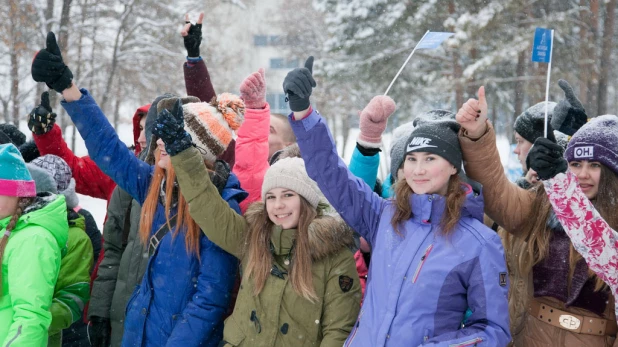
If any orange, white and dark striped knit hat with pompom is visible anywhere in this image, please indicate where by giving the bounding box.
[182,93,245,163]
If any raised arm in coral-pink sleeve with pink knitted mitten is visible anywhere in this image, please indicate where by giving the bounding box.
[234,69,270,213]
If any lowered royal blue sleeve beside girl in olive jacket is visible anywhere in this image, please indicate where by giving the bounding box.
[165,236,238,347]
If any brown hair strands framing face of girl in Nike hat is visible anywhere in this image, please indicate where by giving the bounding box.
[391,175,466,236]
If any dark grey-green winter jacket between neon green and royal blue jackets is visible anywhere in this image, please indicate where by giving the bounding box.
[88,187,149,347]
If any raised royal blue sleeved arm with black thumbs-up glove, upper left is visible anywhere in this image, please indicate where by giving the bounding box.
[32,32,152,202]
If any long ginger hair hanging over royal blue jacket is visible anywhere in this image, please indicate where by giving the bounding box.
[139,149,202,259]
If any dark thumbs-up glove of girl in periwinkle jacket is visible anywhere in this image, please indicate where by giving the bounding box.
[283,56,316,112]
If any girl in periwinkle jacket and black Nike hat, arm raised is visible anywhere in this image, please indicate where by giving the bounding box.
[283,57,510,347]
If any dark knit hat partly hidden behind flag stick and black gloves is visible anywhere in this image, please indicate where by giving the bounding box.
[514,102,556,143]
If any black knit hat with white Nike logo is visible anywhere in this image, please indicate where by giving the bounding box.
[406,120,462,172]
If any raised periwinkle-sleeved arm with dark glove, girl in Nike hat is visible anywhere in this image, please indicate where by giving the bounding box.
[283,57,384,244]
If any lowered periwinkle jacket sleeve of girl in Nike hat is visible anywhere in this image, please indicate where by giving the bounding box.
[423,234,511,347]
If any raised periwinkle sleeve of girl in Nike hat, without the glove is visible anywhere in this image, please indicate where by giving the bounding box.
[289,110,384,244]
